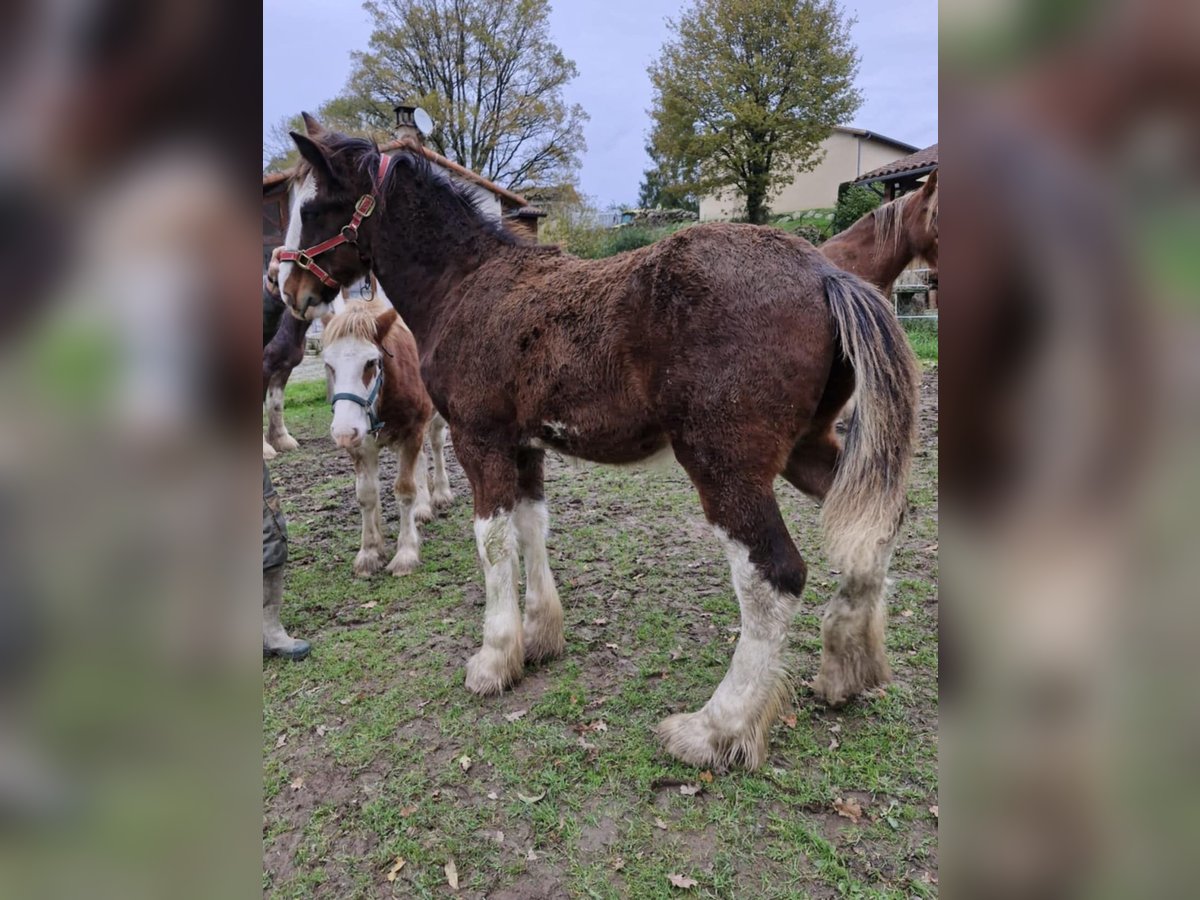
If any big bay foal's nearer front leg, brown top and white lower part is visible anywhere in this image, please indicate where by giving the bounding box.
[455,432,524,695]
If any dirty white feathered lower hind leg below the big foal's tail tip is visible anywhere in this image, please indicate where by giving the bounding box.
[812,568,892,706]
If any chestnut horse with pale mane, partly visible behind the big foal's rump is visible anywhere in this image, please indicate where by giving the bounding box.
[821,169,937,295]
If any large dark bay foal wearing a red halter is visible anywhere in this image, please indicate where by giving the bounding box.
[280,116,918,769]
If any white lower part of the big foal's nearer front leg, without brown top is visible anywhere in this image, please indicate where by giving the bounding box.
[467,510,524,694]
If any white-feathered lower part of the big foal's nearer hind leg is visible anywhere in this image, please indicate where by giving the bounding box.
[659,528,799,769]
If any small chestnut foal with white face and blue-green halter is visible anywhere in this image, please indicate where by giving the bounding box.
[321,300,454,576]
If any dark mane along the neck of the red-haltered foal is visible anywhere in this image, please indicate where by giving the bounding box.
[309,132,524,245]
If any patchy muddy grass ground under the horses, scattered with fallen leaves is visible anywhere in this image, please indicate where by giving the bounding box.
[263,369,937,900]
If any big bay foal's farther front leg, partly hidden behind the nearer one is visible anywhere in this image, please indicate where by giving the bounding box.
[512,450,564,662]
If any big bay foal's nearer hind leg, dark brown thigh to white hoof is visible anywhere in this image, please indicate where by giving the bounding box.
[658,460,806,769]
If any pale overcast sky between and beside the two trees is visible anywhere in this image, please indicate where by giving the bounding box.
[263,0,937,205]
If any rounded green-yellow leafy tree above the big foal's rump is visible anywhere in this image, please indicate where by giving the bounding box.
[649,0,862,222]
